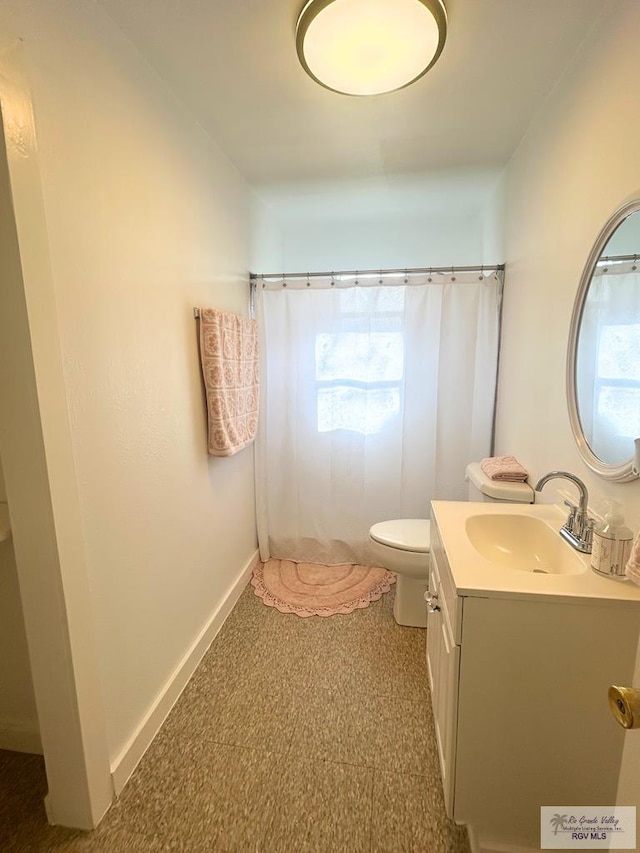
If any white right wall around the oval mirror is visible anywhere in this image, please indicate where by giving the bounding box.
[497,0,640,806]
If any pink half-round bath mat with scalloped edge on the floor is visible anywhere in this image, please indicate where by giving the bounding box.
[251,560,396,616]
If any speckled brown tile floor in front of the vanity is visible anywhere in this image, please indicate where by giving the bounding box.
[0,586,469,853]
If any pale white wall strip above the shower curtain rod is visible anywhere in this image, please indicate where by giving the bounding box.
[251,170,497,273]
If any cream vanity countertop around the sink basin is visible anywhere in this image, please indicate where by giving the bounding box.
[431,501,640,606]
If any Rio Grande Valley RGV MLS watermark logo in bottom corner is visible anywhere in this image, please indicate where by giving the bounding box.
[540,806,637,850]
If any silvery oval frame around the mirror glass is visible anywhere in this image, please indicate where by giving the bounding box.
[566,198,640,483]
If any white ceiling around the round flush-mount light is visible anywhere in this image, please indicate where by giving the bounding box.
[99,0,607,201]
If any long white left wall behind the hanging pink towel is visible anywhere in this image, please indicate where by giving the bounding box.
[0,0,255,776]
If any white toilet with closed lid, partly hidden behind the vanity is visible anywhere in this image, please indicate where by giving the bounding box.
[369,462,535,628]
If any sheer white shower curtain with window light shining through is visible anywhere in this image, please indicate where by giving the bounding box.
[256,272,502,564]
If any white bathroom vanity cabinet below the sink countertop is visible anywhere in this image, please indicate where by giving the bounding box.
[427,503,640,851]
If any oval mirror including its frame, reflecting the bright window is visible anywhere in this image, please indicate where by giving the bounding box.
[567,200,640,482]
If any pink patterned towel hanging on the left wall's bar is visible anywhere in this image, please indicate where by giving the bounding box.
[200,308,259,456]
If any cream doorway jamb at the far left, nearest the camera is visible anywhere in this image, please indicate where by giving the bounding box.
[0,76,113,828]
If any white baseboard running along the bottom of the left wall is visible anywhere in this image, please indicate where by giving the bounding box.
[111,550,259,796]
